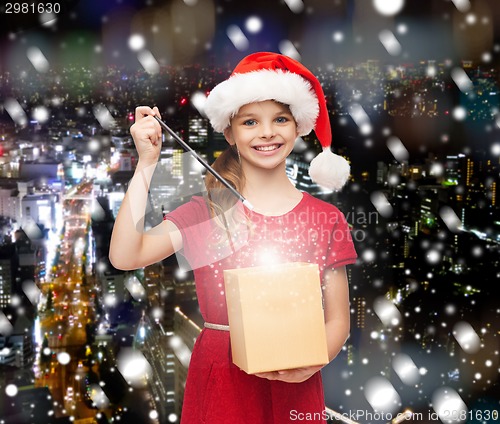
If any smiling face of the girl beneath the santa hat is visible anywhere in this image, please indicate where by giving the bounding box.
[224,100,298,169]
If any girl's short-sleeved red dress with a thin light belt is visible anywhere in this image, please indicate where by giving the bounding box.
[165,193,356,424]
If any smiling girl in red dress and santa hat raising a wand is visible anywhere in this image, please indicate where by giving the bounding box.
[110,53,356,424]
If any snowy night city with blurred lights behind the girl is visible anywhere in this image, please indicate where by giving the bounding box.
[0,0,500,424]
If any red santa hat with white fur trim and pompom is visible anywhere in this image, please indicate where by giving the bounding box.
[204,52,350,190]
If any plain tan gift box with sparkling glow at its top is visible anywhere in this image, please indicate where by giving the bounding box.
[224,262,328,374]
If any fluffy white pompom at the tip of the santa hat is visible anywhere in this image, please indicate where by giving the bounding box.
[309,147,351,191]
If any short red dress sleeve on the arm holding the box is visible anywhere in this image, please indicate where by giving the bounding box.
[326,209,358,268]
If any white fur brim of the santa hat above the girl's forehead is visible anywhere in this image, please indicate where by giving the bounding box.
[204,69,319,136]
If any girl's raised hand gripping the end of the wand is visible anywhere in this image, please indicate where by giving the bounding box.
[130,106,162,164]
